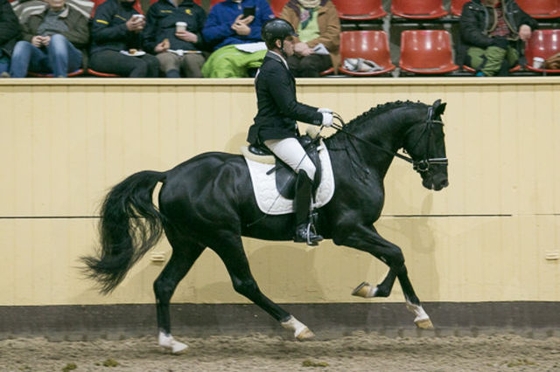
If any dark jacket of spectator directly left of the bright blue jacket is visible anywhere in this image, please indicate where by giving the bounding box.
[143,0,206,53]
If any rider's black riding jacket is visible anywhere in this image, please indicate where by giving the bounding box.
[247,51,323,145]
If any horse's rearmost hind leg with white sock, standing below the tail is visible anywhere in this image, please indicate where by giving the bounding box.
[154,231,206,353]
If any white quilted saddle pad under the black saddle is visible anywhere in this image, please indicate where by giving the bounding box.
[241,145,334,215]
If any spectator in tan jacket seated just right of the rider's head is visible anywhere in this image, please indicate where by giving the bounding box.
[280,0,340,77]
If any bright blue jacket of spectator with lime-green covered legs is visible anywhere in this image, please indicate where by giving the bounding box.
[202,0,274,50]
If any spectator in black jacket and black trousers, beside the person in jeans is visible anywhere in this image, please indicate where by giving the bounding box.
[89,0,159,77]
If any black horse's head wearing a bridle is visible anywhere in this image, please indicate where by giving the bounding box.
[404,99,449,191]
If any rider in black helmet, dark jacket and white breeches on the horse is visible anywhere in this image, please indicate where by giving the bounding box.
[247,18,333,245]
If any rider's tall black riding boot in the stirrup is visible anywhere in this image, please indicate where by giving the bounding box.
[294,170,323,245]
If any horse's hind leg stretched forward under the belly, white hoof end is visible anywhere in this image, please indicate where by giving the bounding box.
[214,237,315,341]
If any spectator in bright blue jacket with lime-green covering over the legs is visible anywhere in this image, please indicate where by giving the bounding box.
[202,0,274,78]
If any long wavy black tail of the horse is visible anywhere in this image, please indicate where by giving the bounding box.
[81,171,165,294]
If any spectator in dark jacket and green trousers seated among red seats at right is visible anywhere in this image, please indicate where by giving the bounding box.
[459,0,538,76]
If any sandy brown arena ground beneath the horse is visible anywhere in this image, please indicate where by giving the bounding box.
[0,332,560,372]
